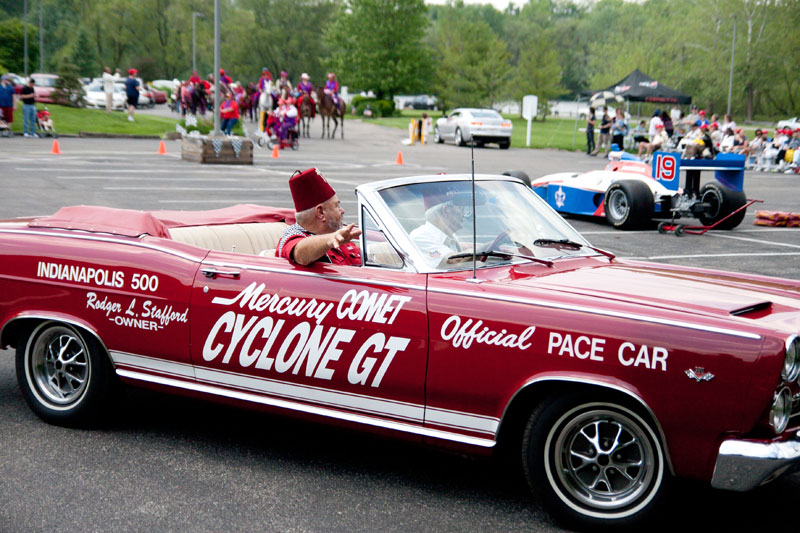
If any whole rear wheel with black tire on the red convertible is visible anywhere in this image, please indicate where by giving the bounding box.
[16,321,115,427]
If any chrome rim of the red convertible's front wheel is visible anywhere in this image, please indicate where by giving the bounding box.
[554,410,655,510]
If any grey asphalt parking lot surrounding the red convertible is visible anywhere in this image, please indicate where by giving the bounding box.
[0,122,800,531]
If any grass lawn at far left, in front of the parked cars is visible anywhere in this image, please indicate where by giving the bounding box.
[11,102,178,136]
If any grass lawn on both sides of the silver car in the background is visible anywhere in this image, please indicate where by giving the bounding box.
[364,109,586,150]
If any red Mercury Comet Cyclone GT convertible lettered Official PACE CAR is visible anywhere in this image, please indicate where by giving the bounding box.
[0,175,800,527]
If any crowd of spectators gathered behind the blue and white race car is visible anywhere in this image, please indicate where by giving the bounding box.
[586,105,800,172]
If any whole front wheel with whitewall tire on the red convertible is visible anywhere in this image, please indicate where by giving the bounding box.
[522,394,671,531]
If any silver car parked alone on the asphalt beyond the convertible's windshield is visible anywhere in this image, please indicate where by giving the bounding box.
[433,108,514,149]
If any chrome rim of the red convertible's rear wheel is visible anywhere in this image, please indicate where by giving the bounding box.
[26,326,91,409]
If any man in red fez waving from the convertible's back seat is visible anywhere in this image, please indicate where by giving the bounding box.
[275,168,361,266]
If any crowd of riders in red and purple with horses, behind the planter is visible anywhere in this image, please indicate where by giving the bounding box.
[171,67,341,141]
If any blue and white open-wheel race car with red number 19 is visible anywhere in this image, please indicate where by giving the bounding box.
[531,152,747,230]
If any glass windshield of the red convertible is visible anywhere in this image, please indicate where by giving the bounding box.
[380,179,595,270]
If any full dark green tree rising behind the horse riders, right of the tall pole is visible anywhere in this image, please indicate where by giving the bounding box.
[325,0,430,99]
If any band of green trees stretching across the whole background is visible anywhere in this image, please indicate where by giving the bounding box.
[0,0,800,120]
